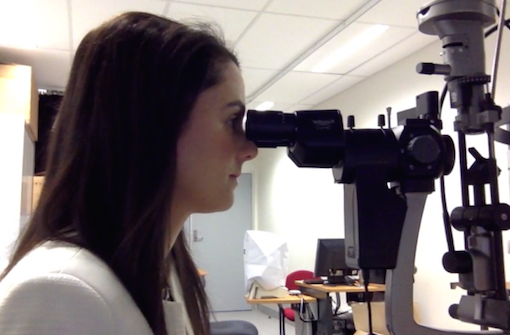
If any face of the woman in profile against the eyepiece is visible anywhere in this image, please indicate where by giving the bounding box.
[173,62,257,214]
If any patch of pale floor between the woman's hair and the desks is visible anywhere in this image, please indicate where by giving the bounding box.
[209,311,295,335]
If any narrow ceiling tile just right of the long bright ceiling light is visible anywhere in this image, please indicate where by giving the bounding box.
[349,32,440,76]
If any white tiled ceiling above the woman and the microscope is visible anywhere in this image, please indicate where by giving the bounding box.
[0,0,437,111]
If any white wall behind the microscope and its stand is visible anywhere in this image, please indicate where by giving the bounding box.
[257,17,510,329]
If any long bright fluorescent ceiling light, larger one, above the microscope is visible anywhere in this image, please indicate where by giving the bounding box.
[312,24,388,72]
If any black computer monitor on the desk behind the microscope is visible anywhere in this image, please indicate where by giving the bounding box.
[315,238,358,284]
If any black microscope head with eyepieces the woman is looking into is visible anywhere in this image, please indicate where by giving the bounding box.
[245,110,454,183]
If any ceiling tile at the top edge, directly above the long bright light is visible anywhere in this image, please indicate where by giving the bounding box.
[266,0,368,20]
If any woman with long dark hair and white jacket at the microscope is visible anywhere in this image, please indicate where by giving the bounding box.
[0,13,257,335]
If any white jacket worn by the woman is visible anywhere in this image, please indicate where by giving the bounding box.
[0,242,192,335]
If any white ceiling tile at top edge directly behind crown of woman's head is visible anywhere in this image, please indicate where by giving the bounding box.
[72,0,166,49]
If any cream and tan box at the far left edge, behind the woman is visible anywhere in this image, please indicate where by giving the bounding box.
[0,63,39,142]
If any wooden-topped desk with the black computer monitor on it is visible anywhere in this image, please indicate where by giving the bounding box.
[295,280,386,335]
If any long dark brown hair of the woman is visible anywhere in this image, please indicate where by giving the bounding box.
[0,12,239,335]
